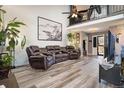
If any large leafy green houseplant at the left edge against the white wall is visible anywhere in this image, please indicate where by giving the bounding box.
[0,9,26,79]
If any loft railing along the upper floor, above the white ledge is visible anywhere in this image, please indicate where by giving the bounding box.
[69,5,124,26]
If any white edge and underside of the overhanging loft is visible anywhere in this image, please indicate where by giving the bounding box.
[67,15,124,33]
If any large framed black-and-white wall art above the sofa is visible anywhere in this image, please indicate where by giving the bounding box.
[38,16,62,41]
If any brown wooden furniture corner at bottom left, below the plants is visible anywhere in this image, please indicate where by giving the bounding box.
[0,71,19,88]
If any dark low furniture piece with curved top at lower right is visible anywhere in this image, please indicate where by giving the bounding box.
[99,65,122,85]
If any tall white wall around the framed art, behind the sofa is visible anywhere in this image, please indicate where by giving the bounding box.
[3,5,69,66]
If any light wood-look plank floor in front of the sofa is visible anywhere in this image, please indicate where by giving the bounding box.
[12,57,123,88]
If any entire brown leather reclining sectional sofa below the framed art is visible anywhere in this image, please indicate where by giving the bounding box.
[26,45,80,69]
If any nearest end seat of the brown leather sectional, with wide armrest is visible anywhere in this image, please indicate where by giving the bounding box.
[26,46,55,70]
